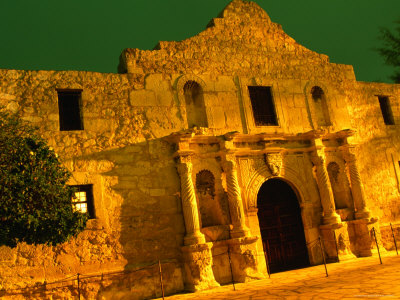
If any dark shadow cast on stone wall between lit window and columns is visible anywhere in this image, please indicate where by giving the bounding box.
[82,139,185,298]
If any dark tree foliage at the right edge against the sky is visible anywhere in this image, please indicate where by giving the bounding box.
[377,20,400,83]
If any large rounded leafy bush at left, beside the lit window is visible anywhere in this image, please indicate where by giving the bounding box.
[0,107,87,247]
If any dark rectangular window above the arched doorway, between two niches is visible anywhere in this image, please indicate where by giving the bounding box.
[248,86,278,126]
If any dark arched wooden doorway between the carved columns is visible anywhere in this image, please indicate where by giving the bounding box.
[257,178,310,272]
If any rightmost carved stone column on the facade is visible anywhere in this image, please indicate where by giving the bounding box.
[340,145,370,219]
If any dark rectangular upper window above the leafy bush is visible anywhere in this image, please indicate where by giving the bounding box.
[58,91,83,131]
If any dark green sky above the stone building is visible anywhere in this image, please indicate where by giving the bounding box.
[0,0,400,82]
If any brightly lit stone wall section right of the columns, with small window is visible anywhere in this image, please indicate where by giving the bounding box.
[349,82,400,222]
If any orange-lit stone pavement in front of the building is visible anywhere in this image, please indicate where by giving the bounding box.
[159,252,400,300]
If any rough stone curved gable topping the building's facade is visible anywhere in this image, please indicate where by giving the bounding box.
[119,0,338,76]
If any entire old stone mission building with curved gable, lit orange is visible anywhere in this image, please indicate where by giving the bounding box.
[0,0,400,299]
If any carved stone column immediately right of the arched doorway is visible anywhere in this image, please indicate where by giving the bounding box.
[311,151,341,225]
